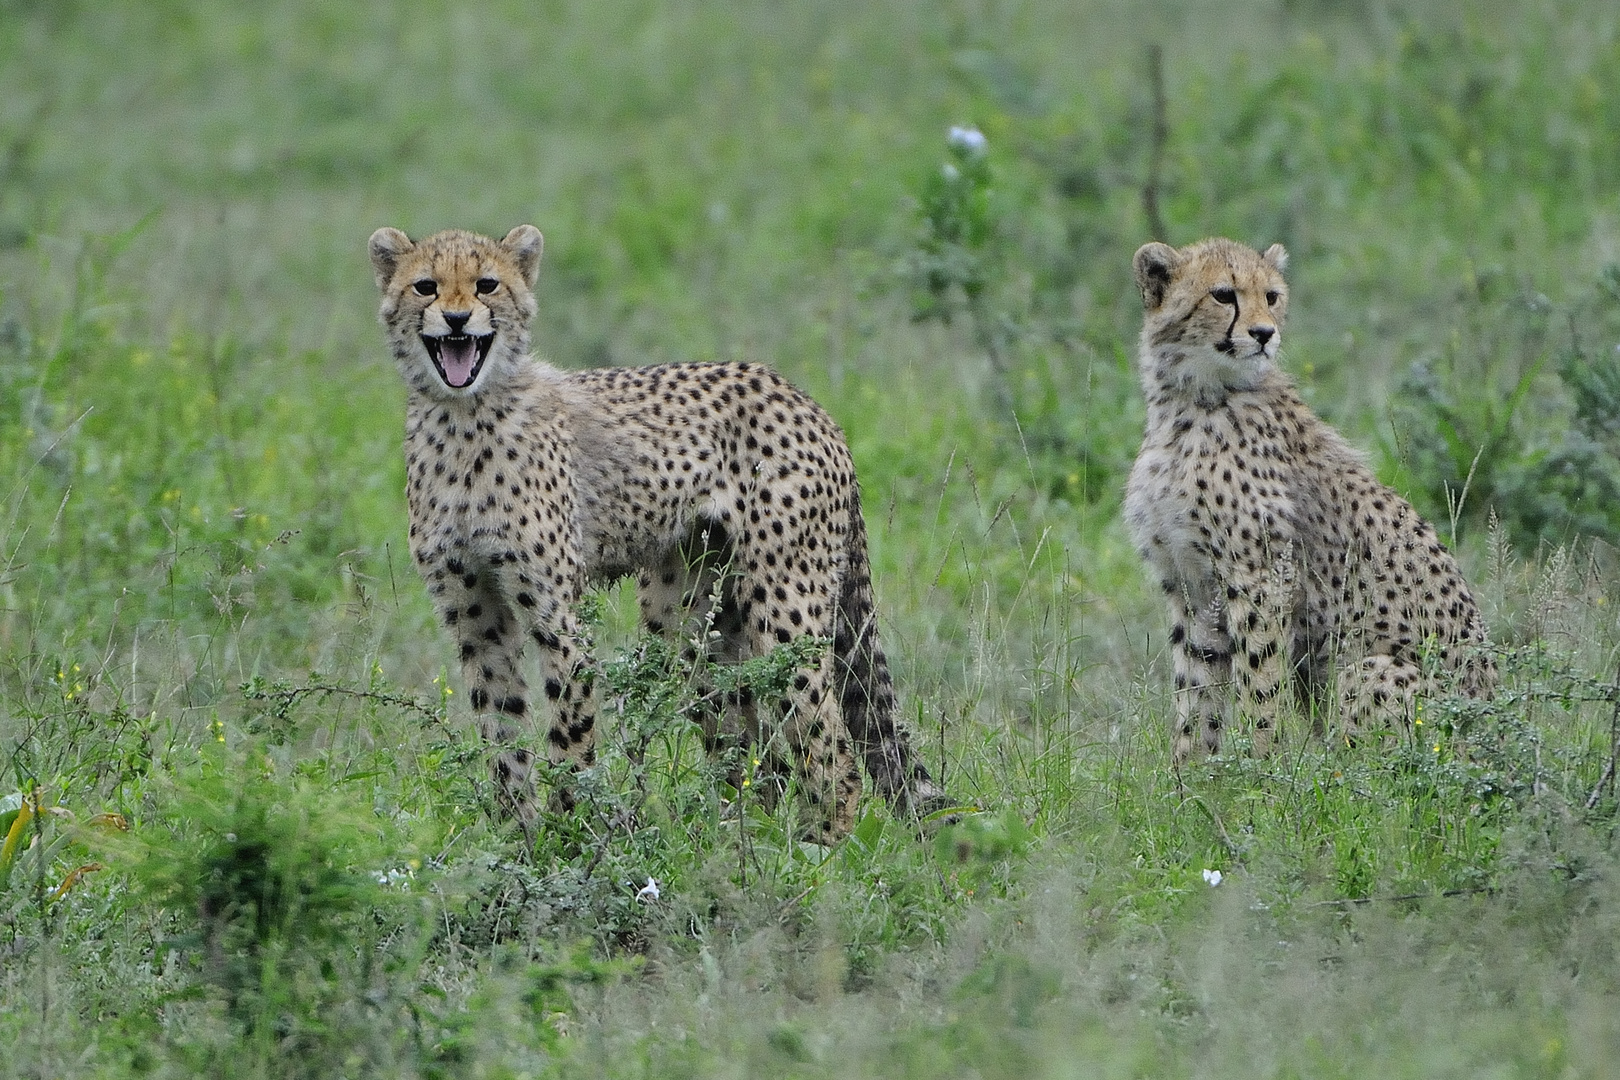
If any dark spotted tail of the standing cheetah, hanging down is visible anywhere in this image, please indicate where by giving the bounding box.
[833,486,953,814]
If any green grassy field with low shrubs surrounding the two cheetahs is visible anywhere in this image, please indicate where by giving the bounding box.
[0,0,1620,1078]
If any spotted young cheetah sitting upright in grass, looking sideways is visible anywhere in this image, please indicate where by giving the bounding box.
[1124,240,1495,764]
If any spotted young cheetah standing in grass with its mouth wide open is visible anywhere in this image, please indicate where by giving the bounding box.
[371,225,946,840]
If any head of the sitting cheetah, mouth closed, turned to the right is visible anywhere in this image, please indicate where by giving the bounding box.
[1134,240,1288,400]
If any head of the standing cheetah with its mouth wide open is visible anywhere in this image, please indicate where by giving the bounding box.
[371,225,544,397]
